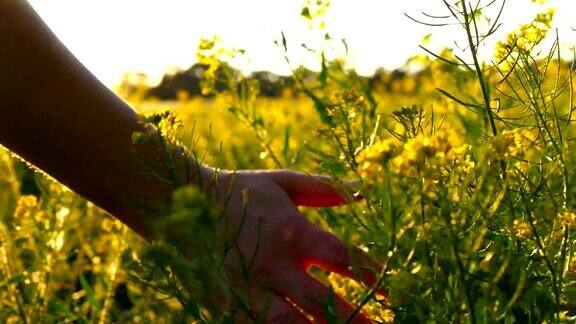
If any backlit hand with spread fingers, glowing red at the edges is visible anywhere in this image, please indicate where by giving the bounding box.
[209,170,380,323]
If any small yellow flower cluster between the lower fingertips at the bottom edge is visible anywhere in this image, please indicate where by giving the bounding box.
[328,273,395,323]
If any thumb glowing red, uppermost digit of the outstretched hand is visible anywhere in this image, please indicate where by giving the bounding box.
[270,170,358,207]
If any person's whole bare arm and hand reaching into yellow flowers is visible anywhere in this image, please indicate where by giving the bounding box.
[0,0,378,323]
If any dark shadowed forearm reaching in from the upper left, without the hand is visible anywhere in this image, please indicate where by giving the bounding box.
[0,0,207,235]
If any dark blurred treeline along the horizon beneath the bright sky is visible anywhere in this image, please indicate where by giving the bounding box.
[141,60,574,100]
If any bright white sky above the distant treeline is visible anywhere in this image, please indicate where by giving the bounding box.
[29,0,576,86]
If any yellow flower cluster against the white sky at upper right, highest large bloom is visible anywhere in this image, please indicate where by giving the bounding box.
[494,9,554,70]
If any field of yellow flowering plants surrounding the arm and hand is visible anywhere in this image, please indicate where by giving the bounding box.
[0,1,576,323]
